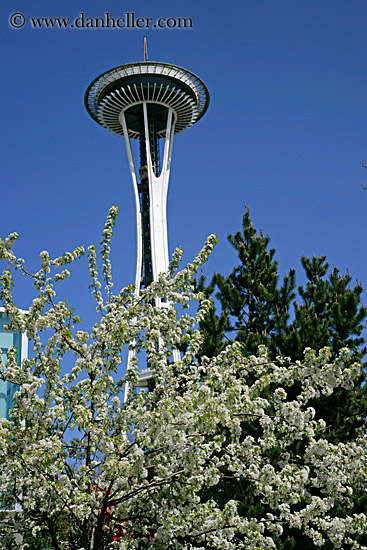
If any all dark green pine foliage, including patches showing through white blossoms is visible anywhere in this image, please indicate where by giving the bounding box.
[198,207,367,550]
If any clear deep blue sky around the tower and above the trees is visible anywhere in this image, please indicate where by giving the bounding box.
[0,0,367,328]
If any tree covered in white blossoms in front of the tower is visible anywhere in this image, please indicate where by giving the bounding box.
[0,208,367,550]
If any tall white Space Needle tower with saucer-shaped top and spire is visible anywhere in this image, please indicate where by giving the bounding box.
[85,41,209,398]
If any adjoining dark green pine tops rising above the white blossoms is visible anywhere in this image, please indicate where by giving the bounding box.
[198,207,367,370]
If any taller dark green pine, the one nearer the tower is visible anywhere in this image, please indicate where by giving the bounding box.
[199,207,295,355]
